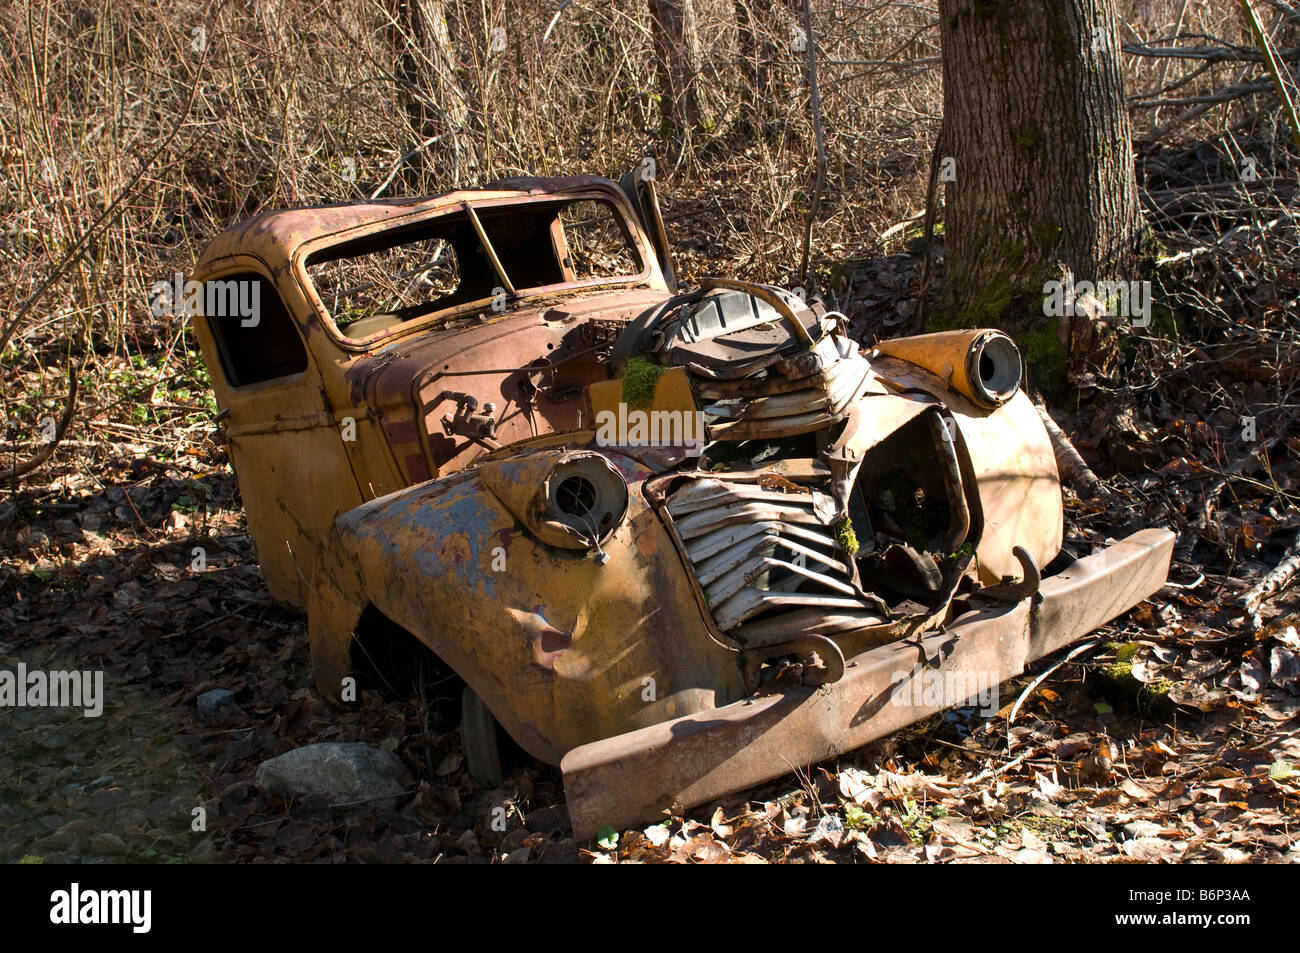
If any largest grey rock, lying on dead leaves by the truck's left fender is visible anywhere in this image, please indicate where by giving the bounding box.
[257,741,406,803]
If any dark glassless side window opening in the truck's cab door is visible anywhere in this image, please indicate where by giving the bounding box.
[198,272,307,387]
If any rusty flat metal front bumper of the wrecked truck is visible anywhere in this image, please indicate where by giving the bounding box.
[560,529,1174,840]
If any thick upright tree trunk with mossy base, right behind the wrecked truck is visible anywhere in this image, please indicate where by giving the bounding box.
[939,0,1144,393]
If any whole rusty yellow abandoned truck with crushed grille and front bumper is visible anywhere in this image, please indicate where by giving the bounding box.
[194,174,1174,839]
